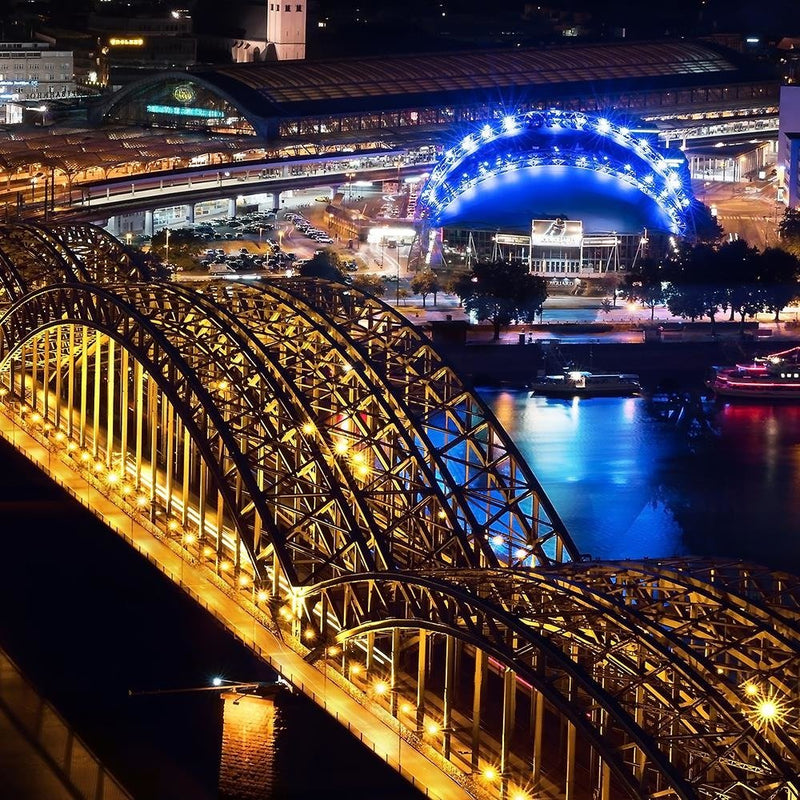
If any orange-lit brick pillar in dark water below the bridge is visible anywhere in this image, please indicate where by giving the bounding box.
[219,692,275,800]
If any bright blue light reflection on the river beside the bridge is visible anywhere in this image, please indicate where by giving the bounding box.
[484,392,685,558]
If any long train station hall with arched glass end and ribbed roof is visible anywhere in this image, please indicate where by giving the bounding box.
[95,41,779,153]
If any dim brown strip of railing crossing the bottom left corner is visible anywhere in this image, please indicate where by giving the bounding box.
[0,650,132,800]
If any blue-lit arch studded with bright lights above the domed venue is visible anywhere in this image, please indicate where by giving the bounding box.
[417,109,691,235]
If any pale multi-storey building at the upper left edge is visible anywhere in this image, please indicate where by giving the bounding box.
[0,42,75,124]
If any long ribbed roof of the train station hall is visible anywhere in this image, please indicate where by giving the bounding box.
[192,40,763,117]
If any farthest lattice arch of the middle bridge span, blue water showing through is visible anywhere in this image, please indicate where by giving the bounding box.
[282,280,577,563]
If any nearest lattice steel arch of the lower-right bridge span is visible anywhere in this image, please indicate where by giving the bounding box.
[300,570,700,800]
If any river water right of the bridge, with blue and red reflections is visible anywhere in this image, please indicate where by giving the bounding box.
[481,390,800,572]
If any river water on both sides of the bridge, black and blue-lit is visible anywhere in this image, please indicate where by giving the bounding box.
[0,391,800,800]
